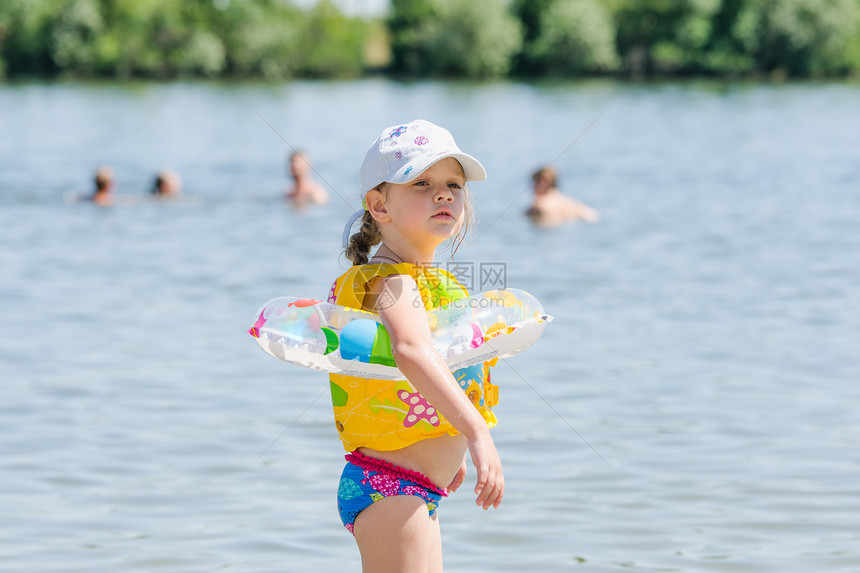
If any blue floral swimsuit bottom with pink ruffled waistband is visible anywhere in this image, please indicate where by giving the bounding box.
[337,452,448,535]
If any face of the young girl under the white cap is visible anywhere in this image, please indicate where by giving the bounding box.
[368,157,466,254]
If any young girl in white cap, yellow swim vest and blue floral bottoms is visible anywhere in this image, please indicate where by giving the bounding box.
[329,120,505,573]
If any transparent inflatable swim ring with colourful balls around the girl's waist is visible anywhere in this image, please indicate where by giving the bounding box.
[248,289,552,380]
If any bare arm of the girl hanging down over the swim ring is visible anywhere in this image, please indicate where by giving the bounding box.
[374,275,505,509]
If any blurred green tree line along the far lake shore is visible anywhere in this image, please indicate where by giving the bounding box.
[0,0,860,79]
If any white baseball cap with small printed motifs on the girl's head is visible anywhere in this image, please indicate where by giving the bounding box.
[358,119,487,194]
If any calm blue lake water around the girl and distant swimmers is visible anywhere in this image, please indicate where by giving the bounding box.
[0,80,860,573]
